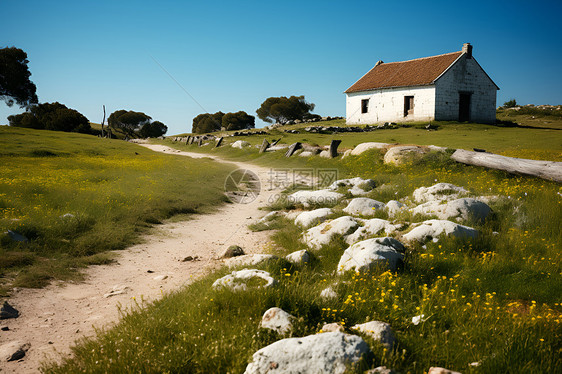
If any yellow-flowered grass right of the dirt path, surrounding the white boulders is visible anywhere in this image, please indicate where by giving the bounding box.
[44,117,562,373]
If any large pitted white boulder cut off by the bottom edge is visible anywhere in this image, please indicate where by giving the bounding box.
[244,332,371,374]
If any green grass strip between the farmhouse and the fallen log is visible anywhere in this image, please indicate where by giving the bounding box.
[170,112,562,161]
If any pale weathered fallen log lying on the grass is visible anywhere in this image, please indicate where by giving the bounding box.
[451,149,562,183]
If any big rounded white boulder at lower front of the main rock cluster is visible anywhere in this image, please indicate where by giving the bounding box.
[338,237,405,274]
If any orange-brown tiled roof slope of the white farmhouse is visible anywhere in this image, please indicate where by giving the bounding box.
[345,51,463,93]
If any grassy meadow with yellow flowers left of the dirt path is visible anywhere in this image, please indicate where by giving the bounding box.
[0,126,229,295]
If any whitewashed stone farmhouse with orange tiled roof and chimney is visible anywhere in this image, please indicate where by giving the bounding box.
[345,43,499,124]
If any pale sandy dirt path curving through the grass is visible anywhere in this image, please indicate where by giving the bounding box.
[0,144,275,373]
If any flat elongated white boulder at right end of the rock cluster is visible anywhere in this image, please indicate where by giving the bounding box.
[411,198,492,220]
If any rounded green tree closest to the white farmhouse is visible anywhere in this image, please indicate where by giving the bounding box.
[256,96,314,124]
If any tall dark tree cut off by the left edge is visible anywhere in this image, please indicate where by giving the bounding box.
[0,47,38,108]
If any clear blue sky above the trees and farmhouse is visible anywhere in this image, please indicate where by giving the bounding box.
[0,0,562,135]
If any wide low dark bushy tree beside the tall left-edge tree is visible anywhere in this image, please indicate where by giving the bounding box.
[8,103,92,134]
